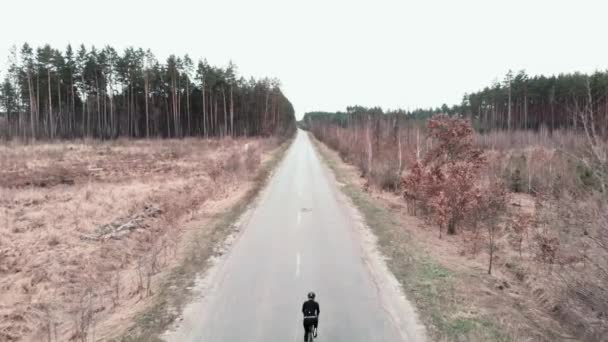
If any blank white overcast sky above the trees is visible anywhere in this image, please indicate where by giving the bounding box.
[0,0,608,116]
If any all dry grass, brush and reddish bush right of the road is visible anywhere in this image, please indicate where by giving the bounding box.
[301,74,608,341]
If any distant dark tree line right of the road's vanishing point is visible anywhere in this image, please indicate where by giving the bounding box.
[303,71,608,137]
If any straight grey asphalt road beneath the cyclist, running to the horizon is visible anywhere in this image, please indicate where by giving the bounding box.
[165,132,421,342]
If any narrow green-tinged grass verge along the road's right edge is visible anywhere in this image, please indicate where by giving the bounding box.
[314,139,509,341]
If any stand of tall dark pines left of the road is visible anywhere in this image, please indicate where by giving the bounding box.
[0,43,295,140]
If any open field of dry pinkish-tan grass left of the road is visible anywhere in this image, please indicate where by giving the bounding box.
[0,139,276,341]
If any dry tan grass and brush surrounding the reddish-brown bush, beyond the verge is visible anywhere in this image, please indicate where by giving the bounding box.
[311,116,608,341]
